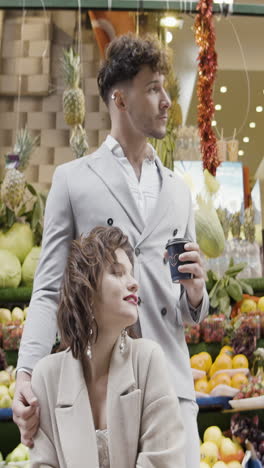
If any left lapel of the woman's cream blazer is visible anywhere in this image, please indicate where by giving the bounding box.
[55,352,99,468]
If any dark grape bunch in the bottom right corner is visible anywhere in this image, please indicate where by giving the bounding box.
[230,413,264,467]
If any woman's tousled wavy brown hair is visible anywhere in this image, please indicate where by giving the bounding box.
[57,226,134,359]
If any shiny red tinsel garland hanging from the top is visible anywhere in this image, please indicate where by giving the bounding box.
[194,0,220,176]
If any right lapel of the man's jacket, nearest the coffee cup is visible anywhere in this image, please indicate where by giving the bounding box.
[138,158,173,247]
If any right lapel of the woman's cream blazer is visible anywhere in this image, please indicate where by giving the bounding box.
[107,338,141,468]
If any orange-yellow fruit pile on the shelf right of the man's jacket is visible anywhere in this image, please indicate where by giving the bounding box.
[190,346,248,393]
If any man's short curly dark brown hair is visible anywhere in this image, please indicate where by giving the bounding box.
[97,33,169,104]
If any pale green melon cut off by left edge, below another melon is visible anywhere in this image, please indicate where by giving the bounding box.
[0,249,21,288]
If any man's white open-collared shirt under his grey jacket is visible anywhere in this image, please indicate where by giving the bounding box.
[104,135,162,223]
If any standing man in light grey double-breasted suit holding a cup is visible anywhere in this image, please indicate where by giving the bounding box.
[13,35,208,468]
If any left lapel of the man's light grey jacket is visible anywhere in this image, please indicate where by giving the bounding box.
[87,144,145,234]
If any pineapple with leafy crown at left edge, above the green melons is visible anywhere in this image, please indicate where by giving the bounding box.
[1,129,39,211]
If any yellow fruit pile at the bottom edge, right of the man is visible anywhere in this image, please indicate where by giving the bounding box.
[200,426,244,468]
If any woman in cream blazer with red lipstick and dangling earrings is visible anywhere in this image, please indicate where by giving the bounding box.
[31,227,185,468]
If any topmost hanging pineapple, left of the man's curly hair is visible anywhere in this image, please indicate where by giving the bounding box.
[62,48,85,126]
